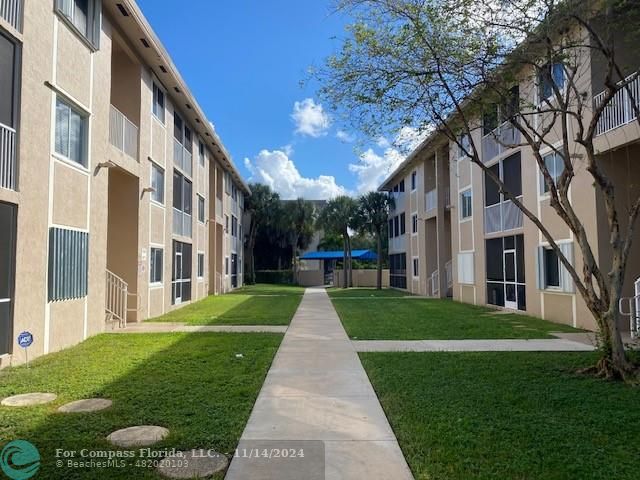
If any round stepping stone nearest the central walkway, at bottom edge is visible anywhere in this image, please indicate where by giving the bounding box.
[157,449,229,478]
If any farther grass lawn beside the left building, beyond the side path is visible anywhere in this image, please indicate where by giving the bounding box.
[149,284,304,325]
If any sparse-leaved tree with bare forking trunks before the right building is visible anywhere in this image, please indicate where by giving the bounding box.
[316,0,640,382]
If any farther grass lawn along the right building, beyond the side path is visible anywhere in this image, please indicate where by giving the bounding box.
[330,289,580,340]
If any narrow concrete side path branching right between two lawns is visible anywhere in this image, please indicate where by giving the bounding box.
[352,338,596,352]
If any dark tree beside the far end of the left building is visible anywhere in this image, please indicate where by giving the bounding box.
[245,183,280,284]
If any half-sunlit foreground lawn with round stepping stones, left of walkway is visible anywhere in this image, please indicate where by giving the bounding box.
[0,333,282,479]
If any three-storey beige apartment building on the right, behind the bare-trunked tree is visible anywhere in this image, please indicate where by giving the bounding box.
[380,22,640,330]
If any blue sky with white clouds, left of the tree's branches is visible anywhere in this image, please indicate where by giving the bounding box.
[138,0,424,200]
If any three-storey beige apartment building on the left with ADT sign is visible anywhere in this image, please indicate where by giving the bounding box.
[0,0,250,367]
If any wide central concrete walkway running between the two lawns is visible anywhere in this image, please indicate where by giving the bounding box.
[226,288,413,480]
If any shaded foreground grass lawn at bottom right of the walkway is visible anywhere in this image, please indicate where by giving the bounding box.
[360,352,640,480]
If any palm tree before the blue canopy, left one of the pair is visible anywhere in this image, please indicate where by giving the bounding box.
[318,195,357,288]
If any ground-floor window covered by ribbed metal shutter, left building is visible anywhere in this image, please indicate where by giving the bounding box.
[48,228,89,302]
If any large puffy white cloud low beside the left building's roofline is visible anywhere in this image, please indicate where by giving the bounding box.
[244,149,349,200]
